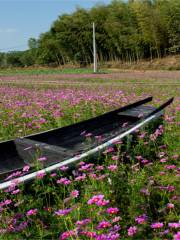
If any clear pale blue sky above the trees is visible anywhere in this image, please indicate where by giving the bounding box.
[0,0,111,52]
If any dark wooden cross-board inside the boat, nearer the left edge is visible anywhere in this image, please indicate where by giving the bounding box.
[14,138,73,166]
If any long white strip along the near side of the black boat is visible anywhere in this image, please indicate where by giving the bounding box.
[0,114,156,190]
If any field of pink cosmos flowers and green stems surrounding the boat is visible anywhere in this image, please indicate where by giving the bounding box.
[0,71,180,240]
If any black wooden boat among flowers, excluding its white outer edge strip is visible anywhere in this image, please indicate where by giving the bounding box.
[0,97,173,179]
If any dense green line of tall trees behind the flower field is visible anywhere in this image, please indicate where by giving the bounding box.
[0,0,180,67]
